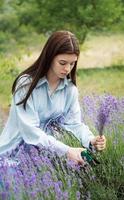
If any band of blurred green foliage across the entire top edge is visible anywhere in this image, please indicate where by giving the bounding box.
[0,0,124,45]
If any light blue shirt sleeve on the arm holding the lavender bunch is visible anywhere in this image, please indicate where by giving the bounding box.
[64,86,95,148]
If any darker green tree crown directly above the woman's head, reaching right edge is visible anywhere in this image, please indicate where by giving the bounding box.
[34,0,124,42]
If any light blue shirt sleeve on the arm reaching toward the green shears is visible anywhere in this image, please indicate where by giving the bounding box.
[13,77,69,155]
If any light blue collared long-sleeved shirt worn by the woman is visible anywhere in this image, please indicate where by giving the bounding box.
[0,75,94,154]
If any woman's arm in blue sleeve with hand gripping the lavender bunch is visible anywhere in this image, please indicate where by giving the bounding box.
[65,86,106,150]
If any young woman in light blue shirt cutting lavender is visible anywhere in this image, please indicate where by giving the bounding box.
[0,31,106,164]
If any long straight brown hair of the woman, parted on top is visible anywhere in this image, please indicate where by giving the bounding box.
[12,31,80,109]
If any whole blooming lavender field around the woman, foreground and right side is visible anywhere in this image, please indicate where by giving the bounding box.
[0,94,124,200]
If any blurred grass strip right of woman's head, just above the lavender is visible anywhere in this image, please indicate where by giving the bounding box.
[77,66,124,97]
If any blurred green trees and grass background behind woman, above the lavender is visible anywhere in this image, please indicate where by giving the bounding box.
[0,0,124,111]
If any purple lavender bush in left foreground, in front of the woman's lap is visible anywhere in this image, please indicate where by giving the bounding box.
[0,145,91,200]
